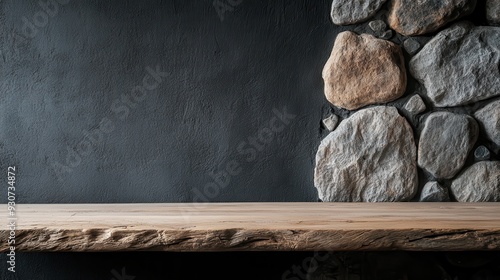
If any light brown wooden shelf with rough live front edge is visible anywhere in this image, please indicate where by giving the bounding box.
[0,203,500,252]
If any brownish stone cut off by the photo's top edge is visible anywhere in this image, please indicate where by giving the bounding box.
[388,0,476,36]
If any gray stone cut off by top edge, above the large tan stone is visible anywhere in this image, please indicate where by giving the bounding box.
[330,0,387,25]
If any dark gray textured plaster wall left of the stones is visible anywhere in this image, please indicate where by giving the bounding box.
[0,0,341,203]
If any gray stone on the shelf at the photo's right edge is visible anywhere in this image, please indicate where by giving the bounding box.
[450,161,500,202]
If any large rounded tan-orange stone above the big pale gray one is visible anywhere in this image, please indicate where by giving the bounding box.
[323,31,406,110]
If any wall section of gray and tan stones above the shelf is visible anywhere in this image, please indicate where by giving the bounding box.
[314,0,500,202]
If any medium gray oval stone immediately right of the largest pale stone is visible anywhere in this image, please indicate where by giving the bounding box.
[418,112,479,179]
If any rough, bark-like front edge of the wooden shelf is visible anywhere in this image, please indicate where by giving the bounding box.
[0,228,500,252]
